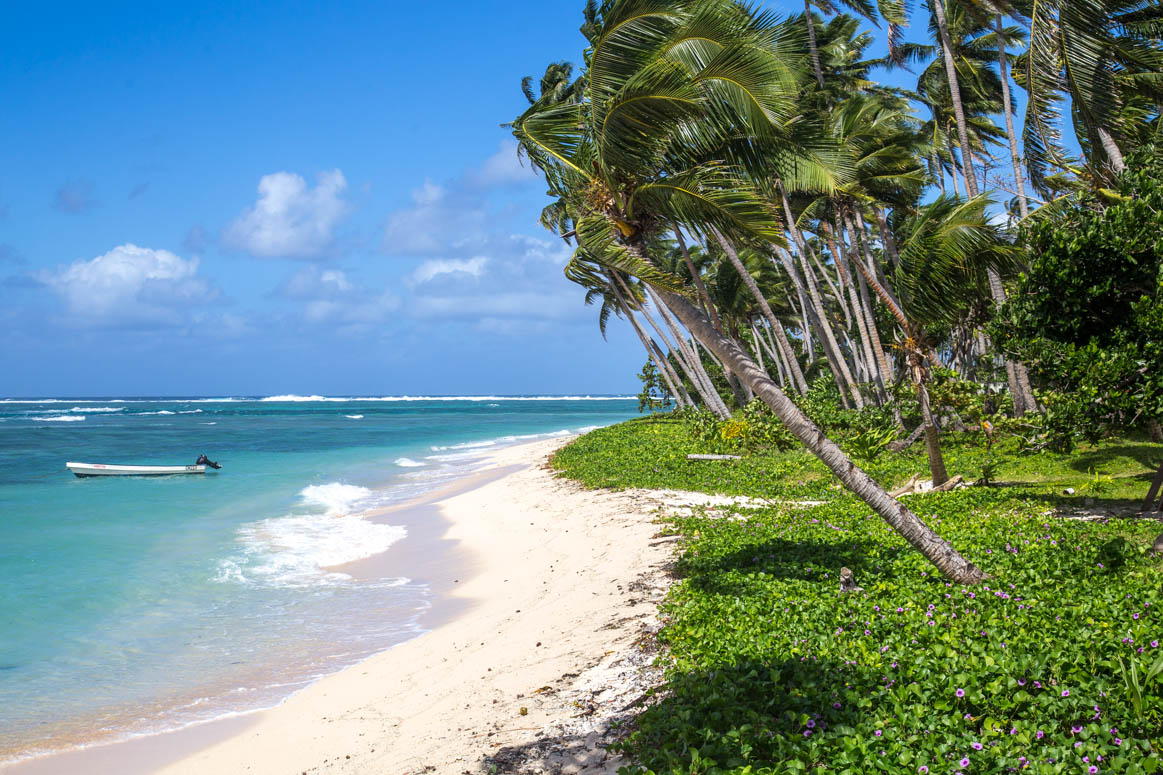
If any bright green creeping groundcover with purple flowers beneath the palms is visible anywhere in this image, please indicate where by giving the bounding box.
[555,419,1163,775]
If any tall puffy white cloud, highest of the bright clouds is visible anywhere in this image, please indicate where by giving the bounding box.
[222,170,351,258]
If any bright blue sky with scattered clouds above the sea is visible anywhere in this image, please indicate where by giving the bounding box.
[0,0,1018,396]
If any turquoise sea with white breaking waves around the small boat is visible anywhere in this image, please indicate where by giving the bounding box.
[0,397,636,761]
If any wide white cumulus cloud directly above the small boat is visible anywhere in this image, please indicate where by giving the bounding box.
[36,243,221,327]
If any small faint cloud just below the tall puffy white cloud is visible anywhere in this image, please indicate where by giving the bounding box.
[276,266,400,329]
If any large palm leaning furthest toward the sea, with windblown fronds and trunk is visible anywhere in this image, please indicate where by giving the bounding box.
[513,0,984,583]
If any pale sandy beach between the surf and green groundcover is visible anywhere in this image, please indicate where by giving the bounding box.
[14,439,673,775]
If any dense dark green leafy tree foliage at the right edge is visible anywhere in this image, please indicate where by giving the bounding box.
[997,149,1163,448]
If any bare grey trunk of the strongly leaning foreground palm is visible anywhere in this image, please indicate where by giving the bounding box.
[657,290,986,584]
